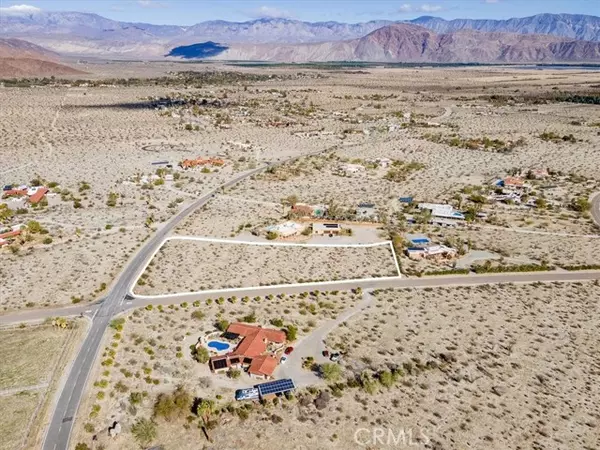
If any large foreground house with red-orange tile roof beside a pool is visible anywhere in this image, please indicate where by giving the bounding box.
[208,322,286,379]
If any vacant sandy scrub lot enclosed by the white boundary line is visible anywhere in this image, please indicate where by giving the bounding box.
[134,238,399,295]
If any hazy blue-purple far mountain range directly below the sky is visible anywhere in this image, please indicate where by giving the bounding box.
[0,11,600,59]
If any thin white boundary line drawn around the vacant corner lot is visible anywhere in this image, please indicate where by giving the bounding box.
[129,236,402,300]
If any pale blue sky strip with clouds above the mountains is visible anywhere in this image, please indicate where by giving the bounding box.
[0,0,600,25]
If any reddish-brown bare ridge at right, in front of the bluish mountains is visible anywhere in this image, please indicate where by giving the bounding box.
[180,23,600,63]
